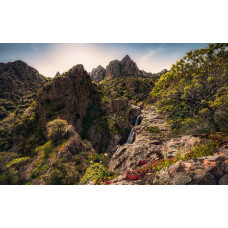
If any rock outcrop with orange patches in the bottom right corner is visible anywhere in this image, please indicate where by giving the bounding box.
[152,147,228,185]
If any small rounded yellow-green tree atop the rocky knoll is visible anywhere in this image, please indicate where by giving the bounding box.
[47,119,68,143]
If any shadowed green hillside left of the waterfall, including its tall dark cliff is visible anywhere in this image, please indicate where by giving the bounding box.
[0,58,157,184]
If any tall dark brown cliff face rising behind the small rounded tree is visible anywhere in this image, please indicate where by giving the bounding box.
[37,65,95,133]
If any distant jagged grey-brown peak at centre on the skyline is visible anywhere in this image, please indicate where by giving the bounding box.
[106,55,142,79]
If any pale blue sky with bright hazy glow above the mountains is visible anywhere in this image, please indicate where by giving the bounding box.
[0,43,208,77]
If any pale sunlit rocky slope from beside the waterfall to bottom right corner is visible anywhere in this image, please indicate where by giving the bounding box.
[109,107,228,184]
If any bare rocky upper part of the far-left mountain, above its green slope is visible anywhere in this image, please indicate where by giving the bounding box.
[0,60,47,95]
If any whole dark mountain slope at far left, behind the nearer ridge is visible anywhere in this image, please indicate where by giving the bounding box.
[0,60,47,120]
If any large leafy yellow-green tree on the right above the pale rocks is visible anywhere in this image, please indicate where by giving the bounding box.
[151,44,228,132]
